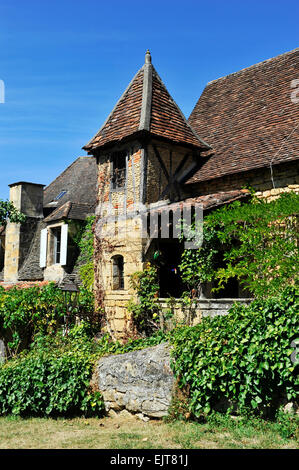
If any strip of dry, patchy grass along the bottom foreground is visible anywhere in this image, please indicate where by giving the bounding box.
[0,415,299,449]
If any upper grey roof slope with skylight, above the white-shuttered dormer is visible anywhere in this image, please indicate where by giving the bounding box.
[44,157,97,209]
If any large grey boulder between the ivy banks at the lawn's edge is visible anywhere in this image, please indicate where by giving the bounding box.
[96,343,174,418]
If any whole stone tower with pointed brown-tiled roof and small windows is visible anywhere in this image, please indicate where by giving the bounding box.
[83,51,210,336]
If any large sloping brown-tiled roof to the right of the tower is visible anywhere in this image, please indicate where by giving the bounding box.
[187,48,299,183]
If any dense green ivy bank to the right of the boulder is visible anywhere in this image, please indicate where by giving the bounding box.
[171,288,299,417]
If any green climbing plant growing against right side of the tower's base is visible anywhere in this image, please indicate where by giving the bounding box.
[128,263,159,334]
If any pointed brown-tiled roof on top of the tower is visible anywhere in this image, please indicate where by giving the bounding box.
[83,51,209,153]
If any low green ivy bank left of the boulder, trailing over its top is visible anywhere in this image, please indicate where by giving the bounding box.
[0,321,166,416]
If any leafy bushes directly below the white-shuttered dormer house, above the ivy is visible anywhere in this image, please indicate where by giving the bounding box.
[0,283,94,356]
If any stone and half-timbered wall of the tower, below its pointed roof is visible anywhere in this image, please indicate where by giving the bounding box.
[95,142,200,339]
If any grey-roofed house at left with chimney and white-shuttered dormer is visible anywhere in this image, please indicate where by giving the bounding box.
[0,157,97,285]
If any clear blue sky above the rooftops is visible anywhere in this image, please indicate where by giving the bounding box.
[0,0,299,199]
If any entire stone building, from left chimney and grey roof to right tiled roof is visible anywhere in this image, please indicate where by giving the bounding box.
[0,49,299,335]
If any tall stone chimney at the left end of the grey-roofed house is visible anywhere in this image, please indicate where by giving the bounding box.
[4,181,44,283]
